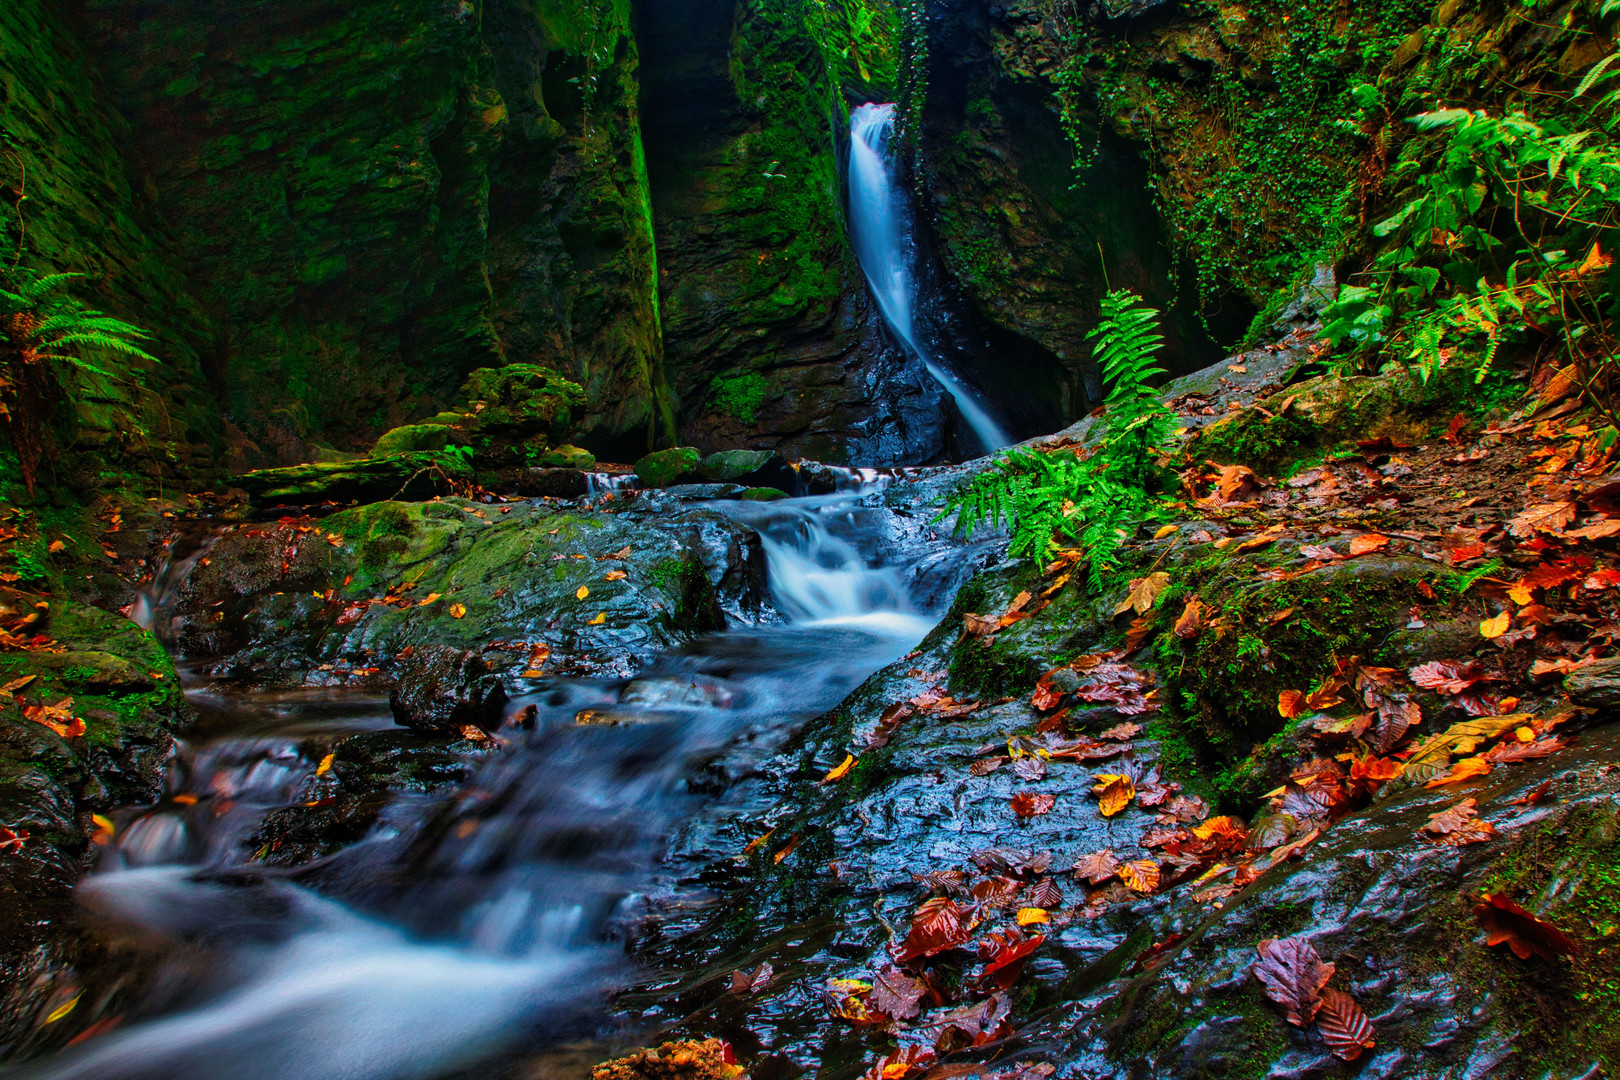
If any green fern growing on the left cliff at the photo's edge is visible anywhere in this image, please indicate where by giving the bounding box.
[0,269,156,494]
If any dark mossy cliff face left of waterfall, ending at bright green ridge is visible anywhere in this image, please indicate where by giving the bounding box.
[80,0,672,465]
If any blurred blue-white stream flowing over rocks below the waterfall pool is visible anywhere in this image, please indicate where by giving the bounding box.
[12,478,962,1080]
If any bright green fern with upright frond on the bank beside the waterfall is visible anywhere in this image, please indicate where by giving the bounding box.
[940,288,1173,588]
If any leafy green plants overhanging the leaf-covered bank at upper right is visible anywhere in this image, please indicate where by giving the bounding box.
[1324,53,1620,420]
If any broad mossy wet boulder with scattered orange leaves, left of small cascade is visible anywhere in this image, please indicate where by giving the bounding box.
[168,492,770,683]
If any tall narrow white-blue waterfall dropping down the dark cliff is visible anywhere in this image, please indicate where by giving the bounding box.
[849,104,1013,452]
